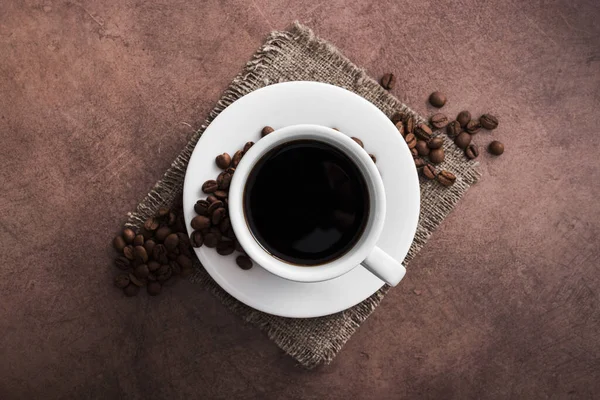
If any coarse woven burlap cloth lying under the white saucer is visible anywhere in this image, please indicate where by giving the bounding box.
[126,23,479,368]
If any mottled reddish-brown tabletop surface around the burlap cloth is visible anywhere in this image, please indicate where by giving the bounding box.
[0,0,600,399]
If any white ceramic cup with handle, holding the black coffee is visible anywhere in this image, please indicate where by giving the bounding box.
[228,124,406,286]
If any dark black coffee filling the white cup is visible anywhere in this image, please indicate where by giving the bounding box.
[244,140,369,266]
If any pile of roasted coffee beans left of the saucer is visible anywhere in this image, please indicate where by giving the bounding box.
[113,205,194,297]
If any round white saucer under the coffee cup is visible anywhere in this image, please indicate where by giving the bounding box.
[183,82,420,318]
